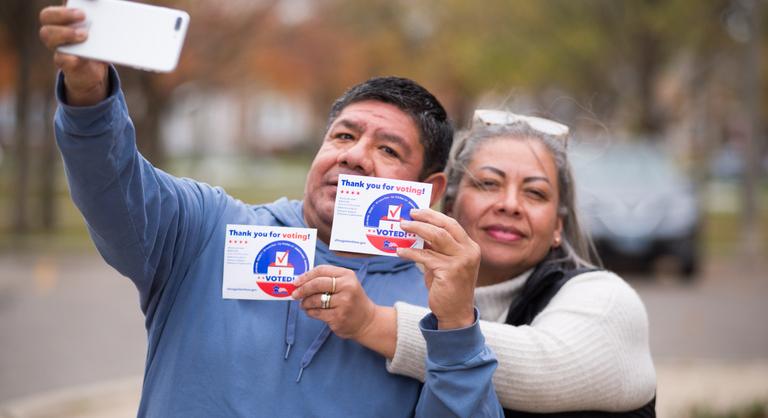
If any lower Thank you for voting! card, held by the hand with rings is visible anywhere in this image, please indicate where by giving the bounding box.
[222,225,317,300]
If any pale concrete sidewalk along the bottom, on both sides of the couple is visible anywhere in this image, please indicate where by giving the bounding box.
[0,359,768,418]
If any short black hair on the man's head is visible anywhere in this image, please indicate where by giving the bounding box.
[326,77,453,179]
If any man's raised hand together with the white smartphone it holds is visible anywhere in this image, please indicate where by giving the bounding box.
[40,0,189,106]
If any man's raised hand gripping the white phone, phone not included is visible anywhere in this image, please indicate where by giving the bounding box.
[40,6,109,106]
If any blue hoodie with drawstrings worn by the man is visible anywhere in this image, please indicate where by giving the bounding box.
[56,69,496,417]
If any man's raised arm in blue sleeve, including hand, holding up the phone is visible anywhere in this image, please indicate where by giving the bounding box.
[40,7,222,313]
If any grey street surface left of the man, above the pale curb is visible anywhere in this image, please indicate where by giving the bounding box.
[0,251,146,402]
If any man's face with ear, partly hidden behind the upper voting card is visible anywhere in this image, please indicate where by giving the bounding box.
[304,100,442,242]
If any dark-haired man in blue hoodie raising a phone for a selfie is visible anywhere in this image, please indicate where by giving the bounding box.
[40,7,498,417]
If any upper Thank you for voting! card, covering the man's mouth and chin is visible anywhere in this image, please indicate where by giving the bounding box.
[329,174,432,256]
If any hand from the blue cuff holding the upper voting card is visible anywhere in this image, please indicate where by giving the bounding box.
[397,209,480,329]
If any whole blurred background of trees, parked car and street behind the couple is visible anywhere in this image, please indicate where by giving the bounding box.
[0,0,768,417]
